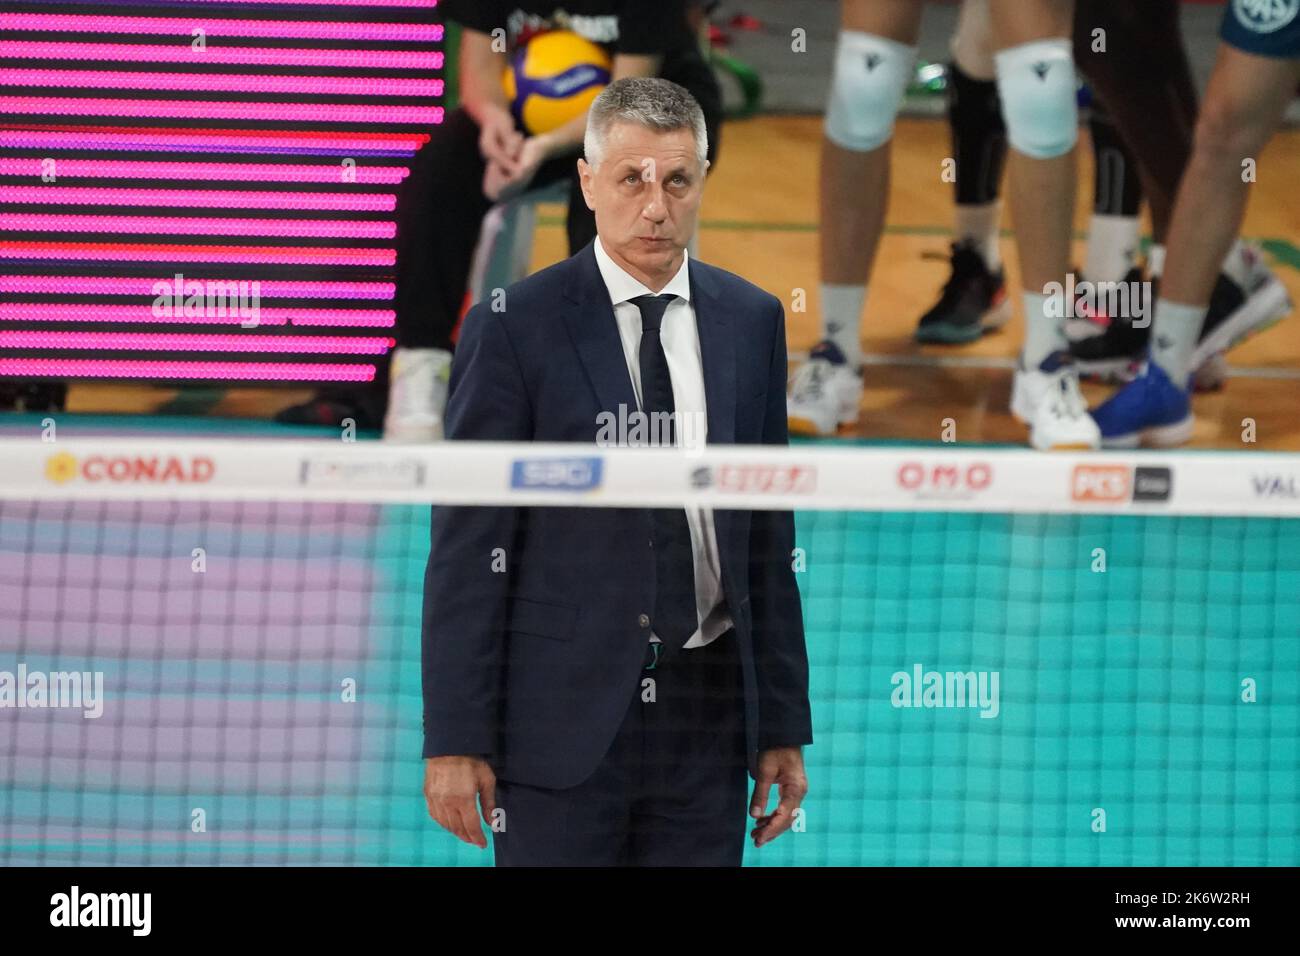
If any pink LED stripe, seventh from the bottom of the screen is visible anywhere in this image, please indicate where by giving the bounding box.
[0,184,397,212]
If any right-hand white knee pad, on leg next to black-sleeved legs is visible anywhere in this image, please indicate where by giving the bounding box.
[993,39,1079,159]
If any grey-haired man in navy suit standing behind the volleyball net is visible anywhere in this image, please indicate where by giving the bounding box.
[423,78,813,866]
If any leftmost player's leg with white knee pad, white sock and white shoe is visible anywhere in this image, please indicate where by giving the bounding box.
[788,0,922,434]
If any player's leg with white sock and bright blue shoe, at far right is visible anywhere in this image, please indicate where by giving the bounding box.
[1093,36,1300,447]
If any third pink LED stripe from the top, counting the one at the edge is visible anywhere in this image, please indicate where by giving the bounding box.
[0,38,445,70]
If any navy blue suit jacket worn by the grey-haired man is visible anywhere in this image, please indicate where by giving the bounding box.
[423,243,813,788]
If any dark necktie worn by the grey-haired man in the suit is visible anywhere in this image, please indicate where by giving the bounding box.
[632,295,698,648]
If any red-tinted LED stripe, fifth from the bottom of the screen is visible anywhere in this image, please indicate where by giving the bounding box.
[0,242,397,267]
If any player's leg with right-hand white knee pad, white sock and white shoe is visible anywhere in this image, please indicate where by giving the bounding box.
[991,0,1100,449]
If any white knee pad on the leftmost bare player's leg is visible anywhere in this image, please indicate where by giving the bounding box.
[826,30,917,152]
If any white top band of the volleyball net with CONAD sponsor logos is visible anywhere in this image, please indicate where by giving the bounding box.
[0,437,1300,518]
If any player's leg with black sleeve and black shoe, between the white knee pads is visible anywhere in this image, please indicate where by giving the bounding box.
[917,0,1011,343]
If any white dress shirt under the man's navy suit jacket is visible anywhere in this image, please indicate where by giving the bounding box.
[595,238,732,648]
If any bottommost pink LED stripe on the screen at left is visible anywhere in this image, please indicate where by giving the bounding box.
[0,359,374,381]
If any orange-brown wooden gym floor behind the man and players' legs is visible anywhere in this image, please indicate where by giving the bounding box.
[69,116,1300,450]
